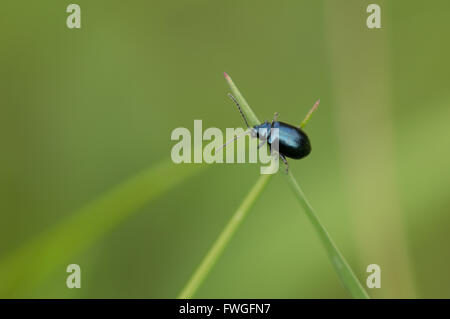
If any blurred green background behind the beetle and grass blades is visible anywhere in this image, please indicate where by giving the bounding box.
[0,0,450,298]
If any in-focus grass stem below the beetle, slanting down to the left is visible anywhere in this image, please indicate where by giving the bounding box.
[178,175,272,299]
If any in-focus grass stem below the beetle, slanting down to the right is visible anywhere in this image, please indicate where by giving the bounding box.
[286,171,369,299]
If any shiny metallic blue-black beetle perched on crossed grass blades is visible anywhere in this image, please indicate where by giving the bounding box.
[224,93,320,171]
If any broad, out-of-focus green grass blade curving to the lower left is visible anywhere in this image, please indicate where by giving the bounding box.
[0,161,204,298]
